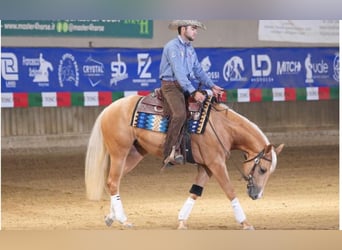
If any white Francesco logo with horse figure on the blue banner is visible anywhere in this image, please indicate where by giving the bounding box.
[22,53,53,87]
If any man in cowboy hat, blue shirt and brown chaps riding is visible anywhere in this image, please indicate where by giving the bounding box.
[159,20,223,166]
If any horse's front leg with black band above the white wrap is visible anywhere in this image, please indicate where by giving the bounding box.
[178,166,211,229]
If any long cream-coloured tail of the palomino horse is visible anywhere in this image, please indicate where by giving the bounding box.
[85,111,109,200]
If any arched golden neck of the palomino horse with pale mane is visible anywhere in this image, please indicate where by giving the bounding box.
[227,109,269,152]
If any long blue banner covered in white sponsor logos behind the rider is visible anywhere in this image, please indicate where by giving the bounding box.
[1,47,339,93]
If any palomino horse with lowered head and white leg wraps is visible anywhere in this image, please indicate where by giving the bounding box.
[85,95,284,229]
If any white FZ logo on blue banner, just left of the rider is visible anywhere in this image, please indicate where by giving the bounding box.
[133,53,157,87]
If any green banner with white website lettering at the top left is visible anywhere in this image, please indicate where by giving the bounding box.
[1,20,153,38]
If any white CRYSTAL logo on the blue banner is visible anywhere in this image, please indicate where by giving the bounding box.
[82,56,105,87]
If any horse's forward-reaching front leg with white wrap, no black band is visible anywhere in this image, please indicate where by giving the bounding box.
[210,164,254,230]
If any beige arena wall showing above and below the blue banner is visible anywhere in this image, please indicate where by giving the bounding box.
[1,20,339,148]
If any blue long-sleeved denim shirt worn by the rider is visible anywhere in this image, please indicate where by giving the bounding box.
[159,36,214,94]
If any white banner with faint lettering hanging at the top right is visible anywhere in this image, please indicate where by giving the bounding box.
[258,20,339,44]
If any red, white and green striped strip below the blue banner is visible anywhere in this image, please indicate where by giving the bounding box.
[1,87,339,108]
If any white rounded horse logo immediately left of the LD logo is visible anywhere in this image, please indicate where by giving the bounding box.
[223,56,247,82]
